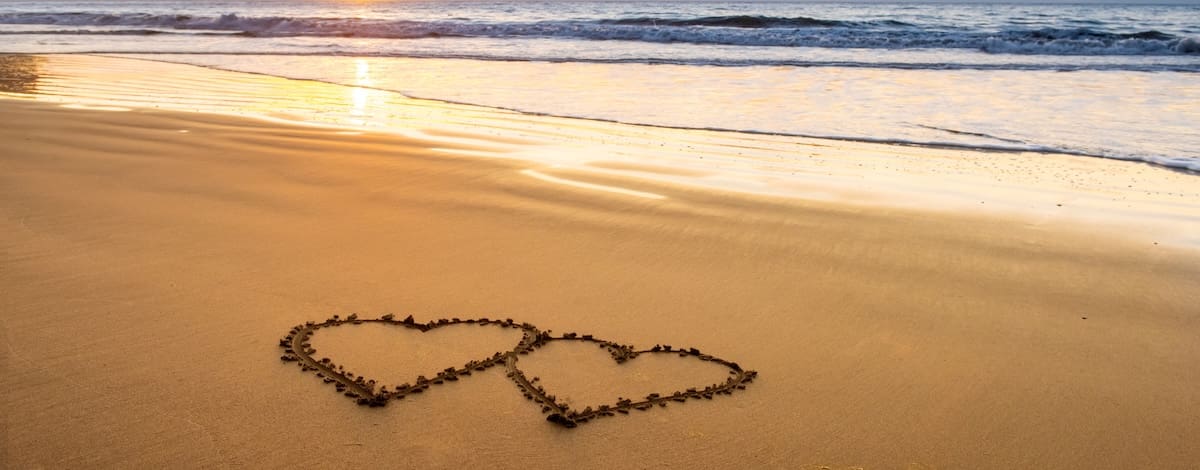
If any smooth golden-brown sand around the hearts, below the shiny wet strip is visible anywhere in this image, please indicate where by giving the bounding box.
[0,54,1200,469]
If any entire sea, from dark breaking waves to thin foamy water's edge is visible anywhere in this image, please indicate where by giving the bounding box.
[0,0,1200,171]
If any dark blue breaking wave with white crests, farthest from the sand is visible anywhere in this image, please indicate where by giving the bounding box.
[0,12,1200,55]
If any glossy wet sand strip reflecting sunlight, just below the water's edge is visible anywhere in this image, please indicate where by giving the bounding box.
[2,55,1200,249]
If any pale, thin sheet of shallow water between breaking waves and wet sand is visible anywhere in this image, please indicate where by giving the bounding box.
[142,54,1200,170]
